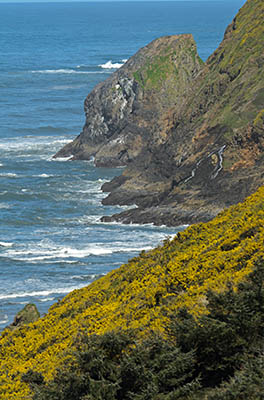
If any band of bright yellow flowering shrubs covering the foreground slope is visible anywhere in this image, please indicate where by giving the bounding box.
[0,187,264,400]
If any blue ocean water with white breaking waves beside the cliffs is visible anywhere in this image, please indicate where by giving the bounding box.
[0,0,244,329]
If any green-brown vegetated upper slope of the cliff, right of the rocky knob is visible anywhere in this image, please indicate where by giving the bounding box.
[165,0,264,169]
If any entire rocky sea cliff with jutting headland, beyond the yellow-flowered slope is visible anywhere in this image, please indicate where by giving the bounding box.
[55,0,264,225]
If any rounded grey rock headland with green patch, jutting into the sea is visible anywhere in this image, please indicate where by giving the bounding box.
[55,35,203,167]
